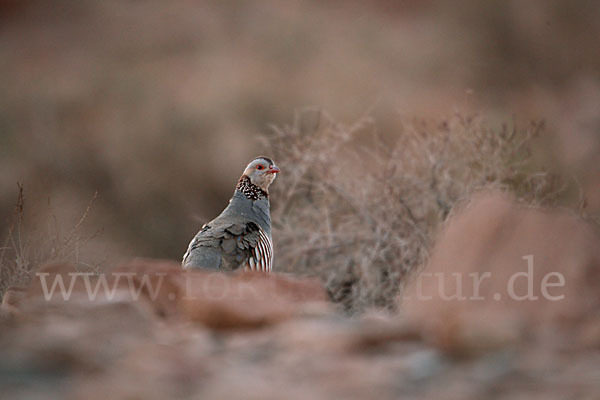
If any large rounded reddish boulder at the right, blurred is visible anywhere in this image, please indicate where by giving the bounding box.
[404,193,600,351]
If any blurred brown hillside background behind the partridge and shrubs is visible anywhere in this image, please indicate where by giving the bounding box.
[0,0,600,286]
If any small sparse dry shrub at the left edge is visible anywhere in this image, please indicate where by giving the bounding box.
[0,183,100,300]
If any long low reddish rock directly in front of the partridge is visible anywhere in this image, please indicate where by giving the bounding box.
[15,259,328,330]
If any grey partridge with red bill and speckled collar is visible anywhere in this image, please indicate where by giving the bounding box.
[182,157,280,272]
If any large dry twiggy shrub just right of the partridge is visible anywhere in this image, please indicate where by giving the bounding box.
[265,110,560,313]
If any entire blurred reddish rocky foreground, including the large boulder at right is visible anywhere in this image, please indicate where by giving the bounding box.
[0,194,600,399]
